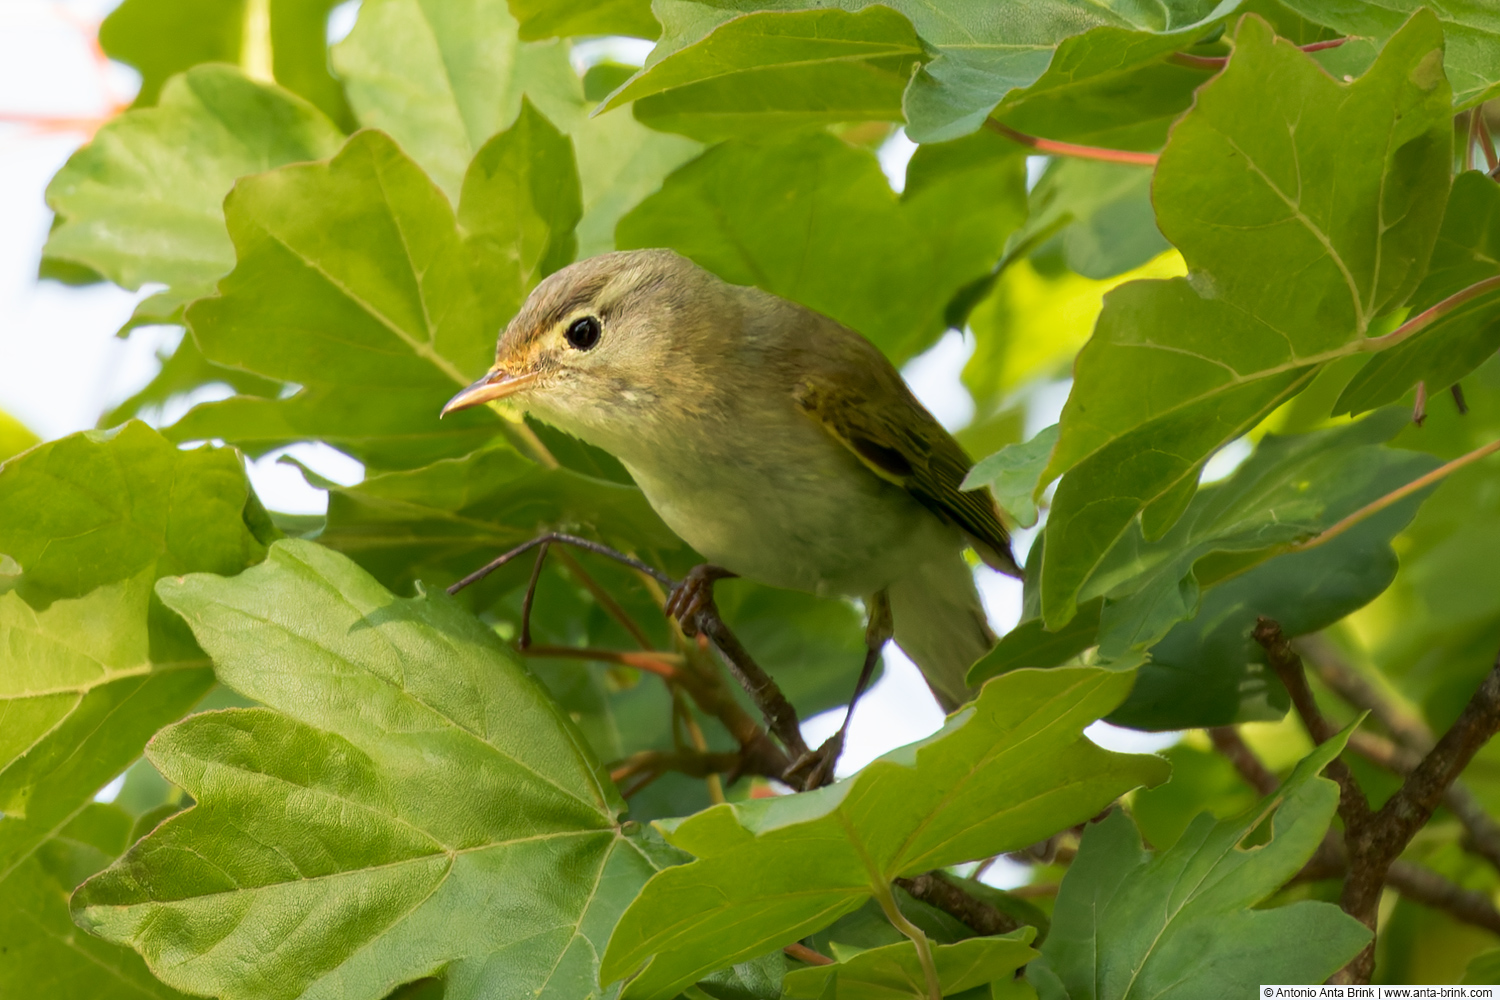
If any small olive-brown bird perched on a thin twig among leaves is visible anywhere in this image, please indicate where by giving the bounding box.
[443,250,1020,743]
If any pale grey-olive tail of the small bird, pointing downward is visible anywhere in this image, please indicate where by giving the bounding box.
[890,556,995,712]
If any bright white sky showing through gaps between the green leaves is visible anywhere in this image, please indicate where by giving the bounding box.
[0,0,1175,885]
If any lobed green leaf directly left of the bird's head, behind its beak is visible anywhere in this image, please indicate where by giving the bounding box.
[168,132,525,468]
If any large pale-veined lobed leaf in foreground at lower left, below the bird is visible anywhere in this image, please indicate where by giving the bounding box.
[74,541,675,1000]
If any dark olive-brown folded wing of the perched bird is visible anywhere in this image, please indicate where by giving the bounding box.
[795,367,1020,576]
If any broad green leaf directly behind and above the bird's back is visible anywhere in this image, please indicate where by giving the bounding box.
[618,135,1025,360]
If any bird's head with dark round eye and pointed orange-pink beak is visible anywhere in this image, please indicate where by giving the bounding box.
[443,250,738,438]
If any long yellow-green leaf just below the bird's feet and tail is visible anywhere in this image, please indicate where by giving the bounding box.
[602,669,1166,999]
